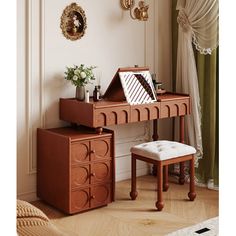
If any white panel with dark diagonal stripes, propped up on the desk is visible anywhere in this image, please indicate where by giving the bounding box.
[119,71,157,105]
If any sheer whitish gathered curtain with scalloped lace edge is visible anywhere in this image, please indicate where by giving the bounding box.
[176,0,219,166]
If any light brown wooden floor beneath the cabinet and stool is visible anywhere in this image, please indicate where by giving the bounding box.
[33,176,218,236]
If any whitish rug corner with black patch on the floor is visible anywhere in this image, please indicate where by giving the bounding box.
[167,217,219,236]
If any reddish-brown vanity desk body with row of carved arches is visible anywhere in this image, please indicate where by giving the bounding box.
[59,93,190,133]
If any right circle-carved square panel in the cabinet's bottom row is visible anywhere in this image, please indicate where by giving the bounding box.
[90,184,111,207]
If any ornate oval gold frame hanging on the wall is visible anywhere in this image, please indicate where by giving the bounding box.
[61,3,87,41]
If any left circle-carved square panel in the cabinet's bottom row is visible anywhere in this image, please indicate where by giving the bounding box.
[70,188,90,213]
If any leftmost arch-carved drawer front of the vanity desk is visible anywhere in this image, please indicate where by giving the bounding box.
[94,106,130,127]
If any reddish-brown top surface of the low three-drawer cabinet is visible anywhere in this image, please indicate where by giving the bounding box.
[40,127,112,141]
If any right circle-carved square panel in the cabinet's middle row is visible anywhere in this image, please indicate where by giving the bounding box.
[90,161,112,184]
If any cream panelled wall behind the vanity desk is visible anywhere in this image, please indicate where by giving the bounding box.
[17,0,170,201]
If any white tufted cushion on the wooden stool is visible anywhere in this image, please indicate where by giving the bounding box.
[130,140,196,161]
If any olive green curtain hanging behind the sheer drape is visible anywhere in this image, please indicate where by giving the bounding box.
[172,0,219,185]
